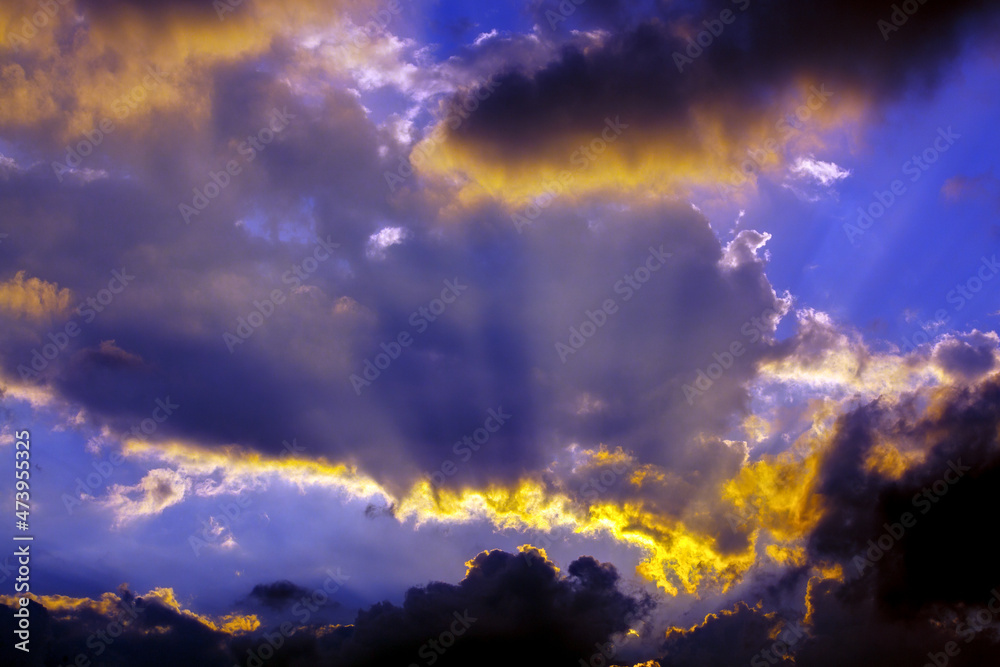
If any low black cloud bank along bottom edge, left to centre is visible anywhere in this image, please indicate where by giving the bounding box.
[0,551,651,667]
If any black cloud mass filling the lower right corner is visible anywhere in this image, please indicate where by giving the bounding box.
[648,376,1000,667]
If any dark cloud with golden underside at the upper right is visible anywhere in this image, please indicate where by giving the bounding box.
[410,1,997,207]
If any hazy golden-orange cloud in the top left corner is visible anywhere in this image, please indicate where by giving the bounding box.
[0,0,367,141]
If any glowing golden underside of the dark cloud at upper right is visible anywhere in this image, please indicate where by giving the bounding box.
[410,81,868,213]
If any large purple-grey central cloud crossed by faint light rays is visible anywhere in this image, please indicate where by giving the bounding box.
[0,57,780,498]
